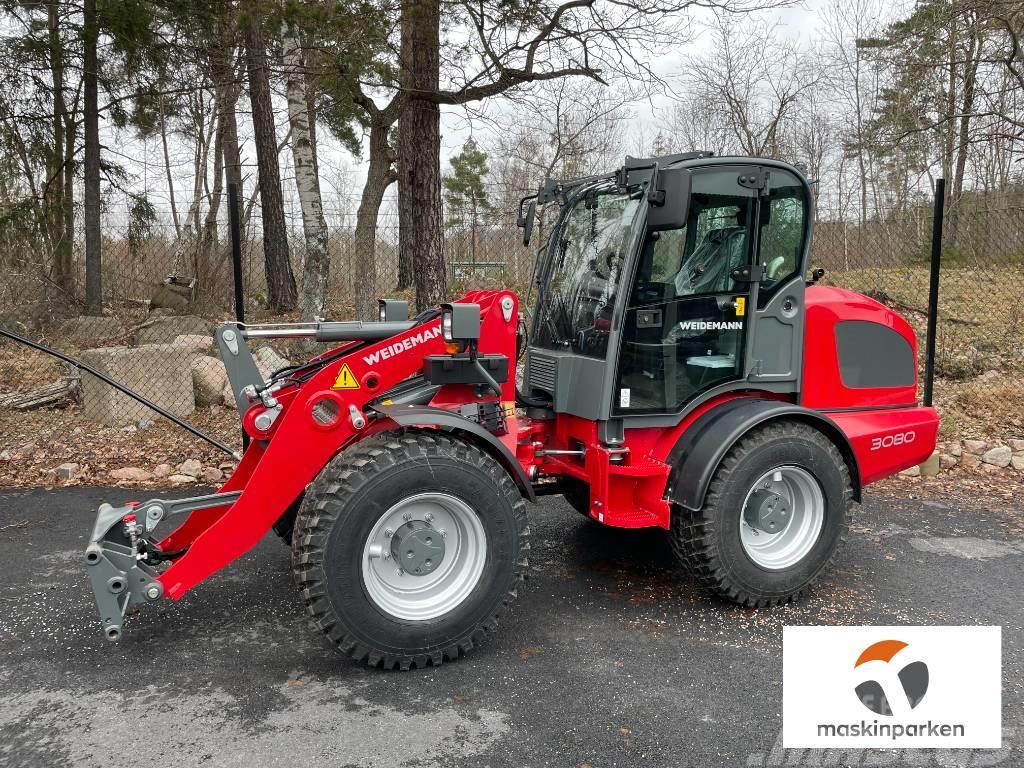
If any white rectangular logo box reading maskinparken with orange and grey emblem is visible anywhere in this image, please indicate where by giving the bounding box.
[782,627,1002,749]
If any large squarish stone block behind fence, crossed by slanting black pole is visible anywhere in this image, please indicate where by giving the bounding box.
[82,344,196,427]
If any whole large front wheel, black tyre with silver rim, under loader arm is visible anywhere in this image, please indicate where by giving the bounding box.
[292,430,529,670]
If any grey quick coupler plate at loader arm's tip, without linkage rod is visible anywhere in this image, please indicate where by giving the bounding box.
[85,504,164,640]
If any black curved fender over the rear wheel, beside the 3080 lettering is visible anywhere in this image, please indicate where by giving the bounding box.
[665,397,860,511]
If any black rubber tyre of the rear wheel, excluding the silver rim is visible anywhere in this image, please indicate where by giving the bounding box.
[670,421,853,608]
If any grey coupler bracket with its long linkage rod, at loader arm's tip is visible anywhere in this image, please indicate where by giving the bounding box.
[85,490,242,641]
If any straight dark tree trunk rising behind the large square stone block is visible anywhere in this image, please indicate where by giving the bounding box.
[82,0,103,314]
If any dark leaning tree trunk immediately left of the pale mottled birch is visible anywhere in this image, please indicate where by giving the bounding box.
[246,3,298,312]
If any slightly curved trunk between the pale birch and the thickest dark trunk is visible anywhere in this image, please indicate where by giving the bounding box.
[355,113,397,321]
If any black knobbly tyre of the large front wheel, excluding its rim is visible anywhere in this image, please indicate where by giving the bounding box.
[292,430,529,670]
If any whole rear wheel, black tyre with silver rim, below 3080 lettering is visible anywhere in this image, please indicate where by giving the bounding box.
[670,421,853,608]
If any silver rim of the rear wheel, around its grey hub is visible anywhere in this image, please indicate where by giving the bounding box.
[739,466,825,570]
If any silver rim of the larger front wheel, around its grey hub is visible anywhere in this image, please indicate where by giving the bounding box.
[362,493,487,622]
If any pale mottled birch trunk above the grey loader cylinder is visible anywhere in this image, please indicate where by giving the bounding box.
[285,30,331,323]
